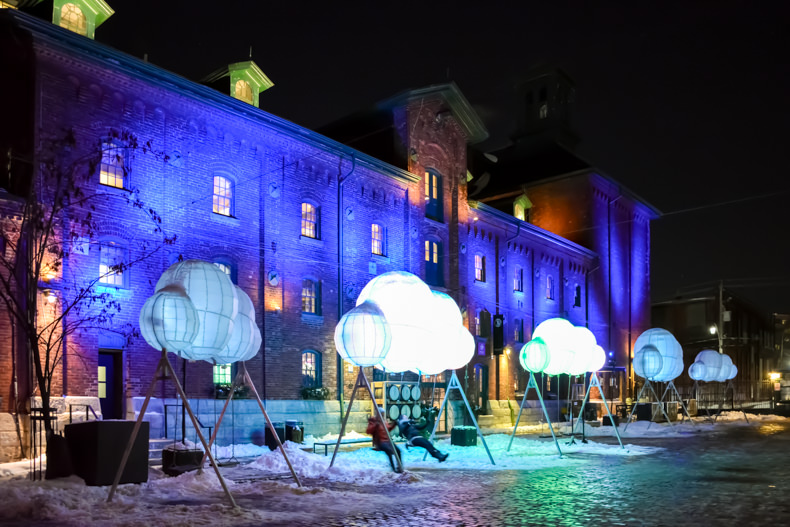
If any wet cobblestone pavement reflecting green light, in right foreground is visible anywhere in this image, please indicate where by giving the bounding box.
[262,422,790,527]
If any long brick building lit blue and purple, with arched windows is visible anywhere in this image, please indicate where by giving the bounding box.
[0,0,656,458]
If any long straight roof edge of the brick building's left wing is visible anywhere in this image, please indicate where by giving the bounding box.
[0,9,421,188]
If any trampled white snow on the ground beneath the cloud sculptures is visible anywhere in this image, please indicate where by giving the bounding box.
[0,412,786,526]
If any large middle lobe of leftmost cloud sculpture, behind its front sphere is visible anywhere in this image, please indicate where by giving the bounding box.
[156,260,239,362]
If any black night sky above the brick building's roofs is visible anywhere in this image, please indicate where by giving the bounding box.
[96,0,790,313]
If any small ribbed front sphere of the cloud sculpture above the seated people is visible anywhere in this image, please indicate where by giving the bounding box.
[335,301,392,367]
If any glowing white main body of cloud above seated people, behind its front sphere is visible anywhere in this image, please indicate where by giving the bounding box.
[352,271,475,375]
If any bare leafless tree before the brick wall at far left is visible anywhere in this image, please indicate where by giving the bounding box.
[0,130,175,433]
